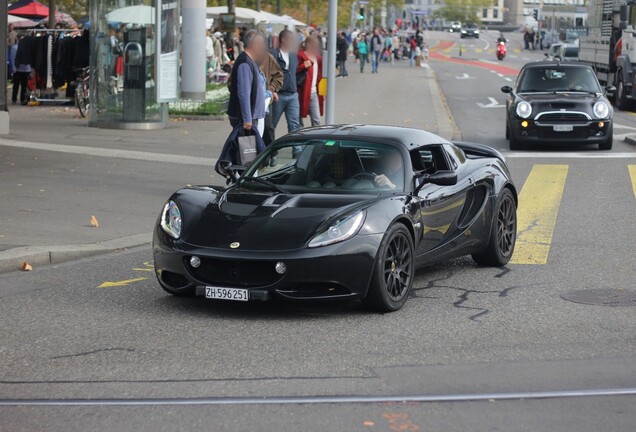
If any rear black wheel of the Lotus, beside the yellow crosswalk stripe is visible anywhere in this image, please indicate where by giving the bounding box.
[472,188,517,267]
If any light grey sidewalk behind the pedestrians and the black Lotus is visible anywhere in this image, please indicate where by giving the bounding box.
[0,61,454,271]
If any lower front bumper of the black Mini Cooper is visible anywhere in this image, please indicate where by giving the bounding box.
[510,118,612,144]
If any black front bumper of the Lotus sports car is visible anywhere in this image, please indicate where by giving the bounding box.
[153,228,382,300]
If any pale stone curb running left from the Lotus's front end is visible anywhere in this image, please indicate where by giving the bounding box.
[0,234,151,273]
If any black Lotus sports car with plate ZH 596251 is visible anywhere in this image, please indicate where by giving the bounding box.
[153,125,517,312]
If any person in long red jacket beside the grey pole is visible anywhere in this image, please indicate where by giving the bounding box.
[296,36,324,126]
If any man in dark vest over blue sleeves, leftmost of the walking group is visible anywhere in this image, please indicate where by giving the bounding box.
[228,30,267,136]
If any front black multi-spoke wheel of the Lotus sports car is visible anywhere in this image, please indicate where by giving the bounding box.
[364,223,415,312]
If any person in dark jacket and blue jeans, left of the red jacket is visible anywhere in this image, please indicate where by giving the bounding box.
[272,30,300,132]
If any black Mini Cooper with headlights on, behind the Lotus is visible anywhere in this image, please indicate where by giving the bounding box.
[501,62,615,150]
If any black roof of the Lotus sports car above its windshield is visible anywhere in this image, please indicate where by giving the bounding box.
[281,124,448,147]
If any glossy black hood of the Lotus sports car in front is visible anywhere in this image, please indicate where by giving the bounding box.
[173,188,380,251]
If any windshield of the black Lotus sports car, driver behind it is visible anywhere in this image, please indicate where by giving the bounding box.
[239,139,405,193]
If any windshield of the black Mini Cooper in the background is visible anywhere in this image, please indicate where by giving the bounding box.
[517,66,601,93]
